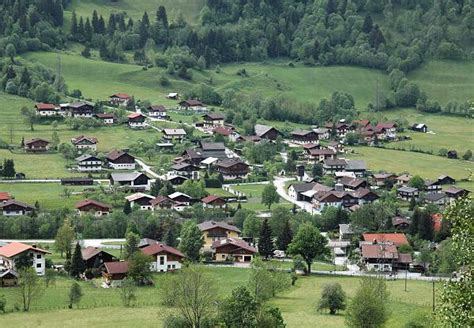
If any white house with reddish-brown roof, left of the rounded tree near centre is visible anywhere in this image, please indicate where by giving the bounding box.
[141,242,184,272]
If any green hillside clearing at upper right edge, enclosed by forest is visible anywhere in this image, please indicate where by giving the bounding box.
[408,60,474,105]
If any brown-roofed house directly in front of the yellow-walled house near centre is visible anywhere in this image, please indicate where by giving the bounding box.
[211,238,257,263]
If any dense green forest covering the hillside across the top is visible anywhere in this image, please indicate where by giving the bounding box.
[0,0,474,122]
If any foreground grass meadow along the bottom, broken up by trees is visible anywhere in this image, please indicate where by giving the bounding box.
[0,268,431,328]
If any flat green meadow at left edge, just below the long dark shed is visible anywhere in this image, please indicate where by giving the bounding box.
[0,182,97,209]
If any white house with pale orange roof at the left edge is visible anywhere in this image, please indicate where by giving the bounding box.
[0,242,51,276]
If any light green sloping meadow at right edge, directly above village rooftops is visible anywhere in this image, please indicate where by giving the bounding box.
[349,147,474,191]
